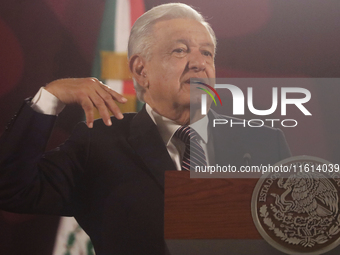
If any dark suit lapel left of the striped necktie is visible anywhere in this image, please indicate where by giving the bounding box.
[128,106,176,188]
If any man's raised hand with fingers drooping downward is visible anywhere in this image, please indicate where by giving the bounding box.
[45,78,127,128]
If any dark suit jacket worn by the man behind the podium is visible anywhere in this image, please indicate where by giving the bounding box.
[0,100,290,255]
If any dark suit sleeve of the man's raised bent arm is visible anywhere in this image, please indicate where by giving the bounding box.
[0,100,88,216]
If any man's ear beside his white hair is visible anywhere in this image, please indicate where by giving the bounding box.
[129,54,149,89]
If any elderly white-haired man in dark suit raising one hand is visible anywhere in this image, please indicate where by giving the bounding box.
[0,4,289,255]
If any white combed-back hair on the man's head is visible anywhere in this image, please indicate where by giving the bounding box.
[128,3,216,102]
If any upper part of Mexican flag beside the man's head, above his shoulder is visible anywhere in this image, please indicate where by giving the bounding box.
[92,0,144,113]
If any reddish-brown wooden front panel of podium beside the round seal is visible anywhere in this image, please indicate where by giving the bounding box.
[164,171,261,239]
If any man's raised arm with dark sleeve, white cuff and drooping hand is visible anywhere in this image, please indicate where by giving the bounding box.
[0,78,126,215]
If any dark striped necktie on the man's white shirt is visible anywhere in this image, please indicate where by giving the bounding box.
[174,126,207,171]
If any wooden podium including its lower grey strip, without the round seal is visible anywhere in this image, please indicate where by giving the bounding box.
[164,171,340,255]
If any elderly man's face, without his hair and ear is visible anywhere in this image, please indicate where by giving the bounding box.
[144,19,215,116]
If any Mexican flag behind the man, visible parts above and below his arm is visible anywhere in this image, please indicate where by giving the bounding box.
[53,0,144,255]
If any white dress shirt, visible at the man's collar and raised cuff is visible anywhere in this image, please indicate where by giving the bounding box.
[31,87,214,170]
